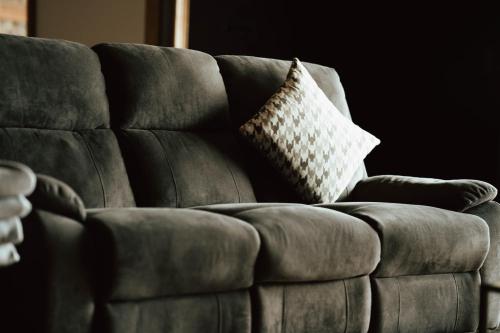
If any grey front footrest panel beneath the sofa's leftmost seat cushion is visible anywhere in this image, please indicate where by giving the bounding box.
[101,291,252,333]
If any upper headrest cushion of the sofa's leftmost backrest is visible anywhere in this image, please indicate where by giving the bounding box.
[0,34,109,130]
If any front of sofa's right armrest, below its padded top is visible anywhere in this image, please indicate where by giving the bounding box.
[466,201,500,329]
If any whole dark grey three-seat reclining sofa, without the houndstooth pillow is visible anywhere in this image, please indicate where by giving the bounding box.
[0,35,500,333]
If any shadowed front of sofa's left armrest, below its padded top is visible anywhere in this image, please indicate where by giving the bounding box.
[0,209,94,333]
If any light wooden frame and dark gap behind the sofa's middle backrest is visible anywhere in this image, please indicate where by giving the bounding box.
[145,0,190,48]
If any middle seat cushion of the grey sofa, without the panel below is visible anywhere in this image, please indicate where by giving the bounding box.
[197,204,380,282]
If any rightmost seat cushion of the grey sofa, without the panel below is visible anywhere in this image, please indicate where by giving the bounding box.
[320,202,489,277]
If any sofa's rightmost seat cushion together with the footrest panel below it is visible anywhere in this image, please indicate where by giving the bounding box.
[321,203,489,333]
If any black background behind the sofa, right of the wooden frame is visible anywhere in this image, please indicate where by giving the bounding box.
[190,0,500,186]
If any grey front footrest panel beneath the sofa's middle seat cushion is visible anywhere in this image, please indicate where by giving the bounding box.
[252,277,371,333]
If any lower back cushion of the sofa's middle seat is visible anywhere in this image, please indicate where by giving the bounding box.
[118,130,255,207]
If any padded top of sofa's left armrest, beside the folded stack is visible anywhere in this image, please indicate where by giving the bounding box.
[29,174,87,222]
